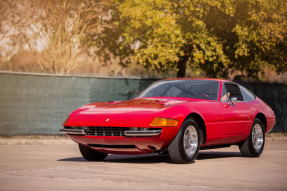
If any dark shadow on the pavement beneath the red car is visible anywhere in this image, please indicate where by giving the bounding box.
[58,151,241,164]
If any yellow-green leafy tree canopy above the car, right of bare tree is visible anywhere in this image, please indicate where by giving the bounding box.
[96,0,287,78]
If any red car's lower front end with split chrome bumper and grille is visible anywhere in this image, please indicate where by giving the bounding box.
[60,127,179,154]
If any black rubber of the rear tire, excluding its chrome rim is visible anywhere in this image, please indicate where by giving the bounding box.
[239,118,265,157]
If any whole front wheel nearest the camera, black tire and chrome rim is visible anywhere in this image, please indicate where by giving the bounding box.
[168,118,200,164]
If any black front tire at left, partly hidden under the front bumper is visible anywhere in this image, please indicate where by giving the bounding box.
[79,144,108,161]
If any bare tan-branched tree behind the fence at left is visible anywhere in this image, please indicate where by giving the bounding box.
[1,0,112,74]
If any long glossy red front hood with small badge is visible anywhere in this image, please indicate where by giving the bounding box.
[66,99,186,127]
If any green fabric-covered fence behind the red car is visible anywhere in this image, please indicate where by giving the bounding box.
[0,73,287,135]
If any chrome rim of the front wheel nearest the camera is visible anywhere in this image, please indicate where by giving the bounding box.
[183,125,198,157]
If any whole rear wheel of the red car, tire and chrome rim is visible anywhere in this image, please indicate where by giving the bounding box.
[239,118,265,157]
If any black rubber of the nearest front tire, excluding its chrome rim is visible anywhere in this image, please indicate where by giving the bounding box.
[168,118,200,164]
